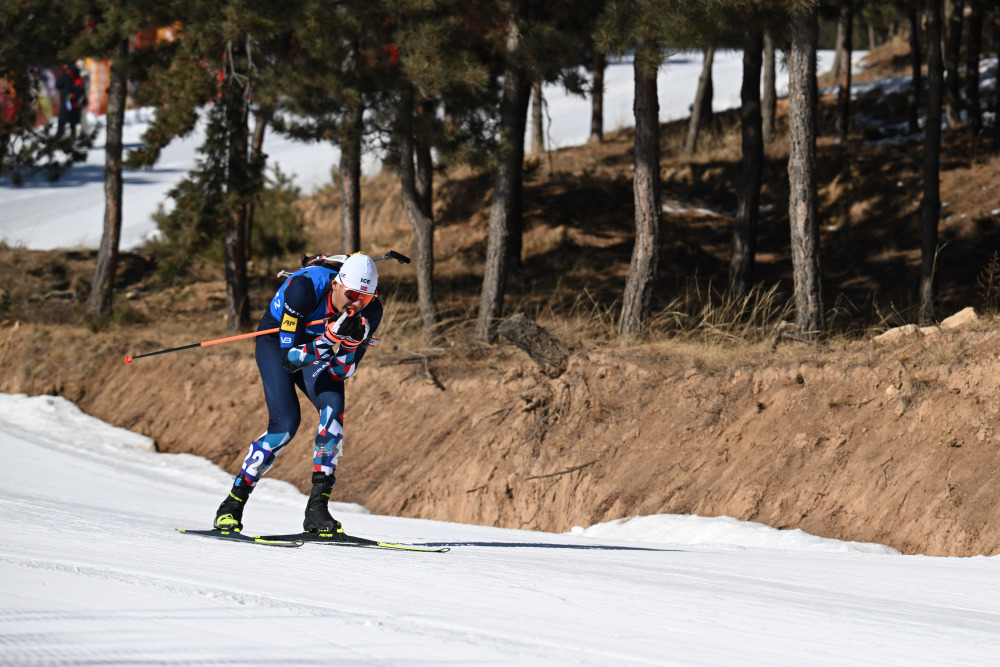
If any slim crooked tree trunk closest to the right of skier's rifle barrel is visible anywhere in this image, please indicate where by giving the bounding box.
[399,89,438,345]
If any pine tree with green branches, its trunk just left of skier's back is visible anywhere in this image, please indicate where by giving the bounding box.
[129,0,294,330]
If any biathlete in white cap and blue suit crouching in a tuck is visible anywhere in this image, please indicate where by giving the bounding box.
[215,253,382,533]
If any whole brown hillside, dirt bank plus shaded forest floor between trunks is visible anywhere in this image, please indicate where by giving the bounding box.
[0,39,1000,555]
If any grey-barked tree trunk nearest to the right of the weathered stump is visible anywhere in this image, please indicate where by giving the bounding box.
[618,42,662,342]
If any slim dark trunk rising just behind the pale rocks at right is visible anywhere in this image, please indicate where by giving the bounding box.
[920,0,944,323]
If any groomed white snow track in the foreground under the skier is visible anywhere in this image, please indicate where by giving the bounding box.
[0,394,1000,667]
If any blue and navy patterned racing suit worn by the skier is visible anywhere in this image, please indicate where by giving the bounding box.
[235,266,382,486]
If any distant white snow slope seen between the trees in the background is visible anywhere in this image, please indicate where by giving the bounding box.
[0,51,840,252]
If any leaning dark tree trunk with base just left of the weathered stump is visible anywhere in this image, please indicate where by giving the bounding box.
[476,0,531,343]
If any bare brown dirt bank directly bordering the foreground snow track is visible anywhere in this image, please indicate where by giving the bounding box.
[0,323,1000,556]
